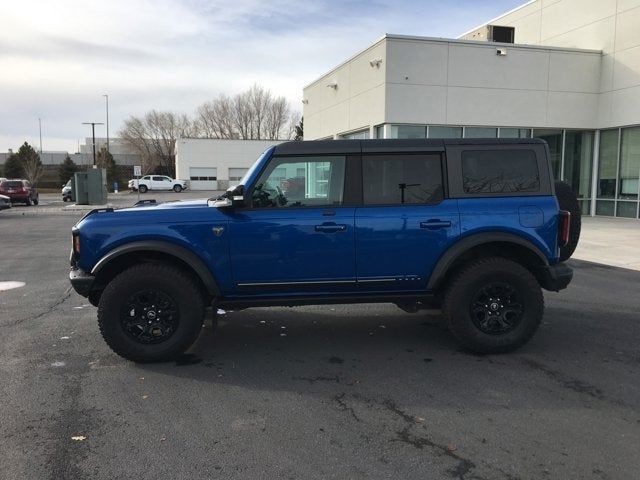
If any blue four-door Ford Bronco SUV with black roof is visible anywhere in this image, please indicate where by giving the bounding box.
[70,139,580,362]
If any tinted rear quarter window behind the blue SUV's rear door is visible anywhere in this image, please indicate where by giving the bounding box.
[461,149,540,194]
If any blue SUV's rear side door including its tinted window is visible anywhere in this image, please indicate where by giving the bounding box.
[355,152,460,291]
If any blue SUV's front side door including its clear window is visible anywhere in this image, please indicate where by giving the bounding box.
[228,155,355,294]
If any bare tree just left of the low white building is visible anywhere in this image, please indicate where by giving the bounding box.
[118,110,197,175]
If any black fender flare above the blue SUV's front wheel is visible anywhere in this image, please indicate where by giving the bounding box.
[91,240,220,297]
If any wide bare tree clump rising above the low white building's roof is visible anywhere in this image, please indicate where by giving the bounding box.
[197,85,292,140]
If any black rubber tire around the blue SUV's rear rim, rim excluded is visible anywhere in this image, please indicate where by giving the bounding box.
[442,257,544,353]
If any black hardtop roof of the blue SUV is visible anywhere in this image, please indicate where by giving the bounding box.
[274,138,545,155]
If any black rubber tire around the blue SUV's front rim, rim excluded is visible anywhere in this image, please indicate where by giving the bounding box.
[98,264,204,363]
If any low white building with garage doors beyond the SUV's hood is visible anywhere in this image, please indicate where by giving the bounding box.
[176,138,282,190]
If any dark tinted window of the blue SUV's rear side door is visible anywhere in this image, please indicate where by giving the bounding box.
[362,153,444,205]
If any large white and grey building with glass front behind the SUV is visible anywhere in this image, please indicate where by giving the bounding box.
[303,0,640,218]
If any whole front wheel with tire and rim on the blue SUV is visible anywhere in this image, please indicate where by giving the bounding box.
[98,264,204,363]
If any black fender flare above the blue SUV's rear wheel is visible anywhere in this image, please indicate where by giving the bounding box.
[427,232,549,290]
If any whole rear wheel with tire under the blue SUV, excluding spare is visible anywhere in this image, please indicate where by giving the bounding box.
[442,257,544,353]
